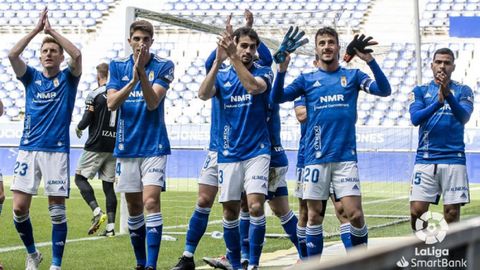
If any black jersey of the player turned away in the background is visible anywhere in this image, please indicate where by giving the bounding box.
[78,85,117,152]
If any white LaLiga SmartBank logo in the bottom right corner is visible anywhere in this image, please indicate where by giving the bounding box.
[397,211,467,269]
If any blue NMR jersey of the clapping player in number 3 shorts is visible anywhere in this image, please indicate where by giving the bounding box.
[215,63,273,163]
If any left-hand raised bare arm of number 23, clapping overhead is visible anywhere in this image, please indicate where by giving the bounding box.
[8,8,47,77]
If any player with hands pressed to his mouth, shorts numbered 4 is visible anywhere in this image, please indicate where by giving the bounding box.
[107,20,174,269]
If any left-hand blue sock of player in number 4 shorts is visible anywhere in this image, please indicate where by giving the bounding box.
[128,214,147,266]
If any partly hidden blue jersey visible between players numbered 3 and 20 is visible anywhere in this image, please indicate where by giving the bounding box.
[267,102,288,168]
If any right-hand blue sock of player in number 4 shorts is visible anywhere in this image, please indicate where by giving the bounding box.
[145,213,163,269]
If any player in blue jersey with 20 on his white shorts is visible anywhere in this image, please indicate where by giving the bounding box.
[272,27,391,256]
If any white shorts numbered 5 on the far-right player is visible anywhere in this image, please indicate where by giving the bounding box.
[410,164,470,205]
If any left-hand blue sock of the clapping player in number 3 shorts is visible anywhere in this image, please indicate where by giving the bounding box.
[223,219,242,269]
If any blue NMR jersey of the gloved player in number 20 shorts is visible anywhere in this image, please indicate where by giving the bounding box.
[272,61,391,166]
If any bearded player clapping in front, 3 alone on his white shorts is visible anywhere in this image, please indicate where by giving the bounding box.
[199,27,273,269]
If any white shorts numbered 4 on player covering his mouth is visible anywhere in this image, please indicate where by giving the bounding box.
[115,156,167,193]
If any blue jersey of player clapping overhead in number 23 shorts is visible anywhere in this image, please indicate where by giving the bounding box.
[18,66,80,153]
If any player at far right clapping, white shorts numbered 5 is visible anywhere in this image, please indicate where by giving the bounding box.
[410,48,474,231]
